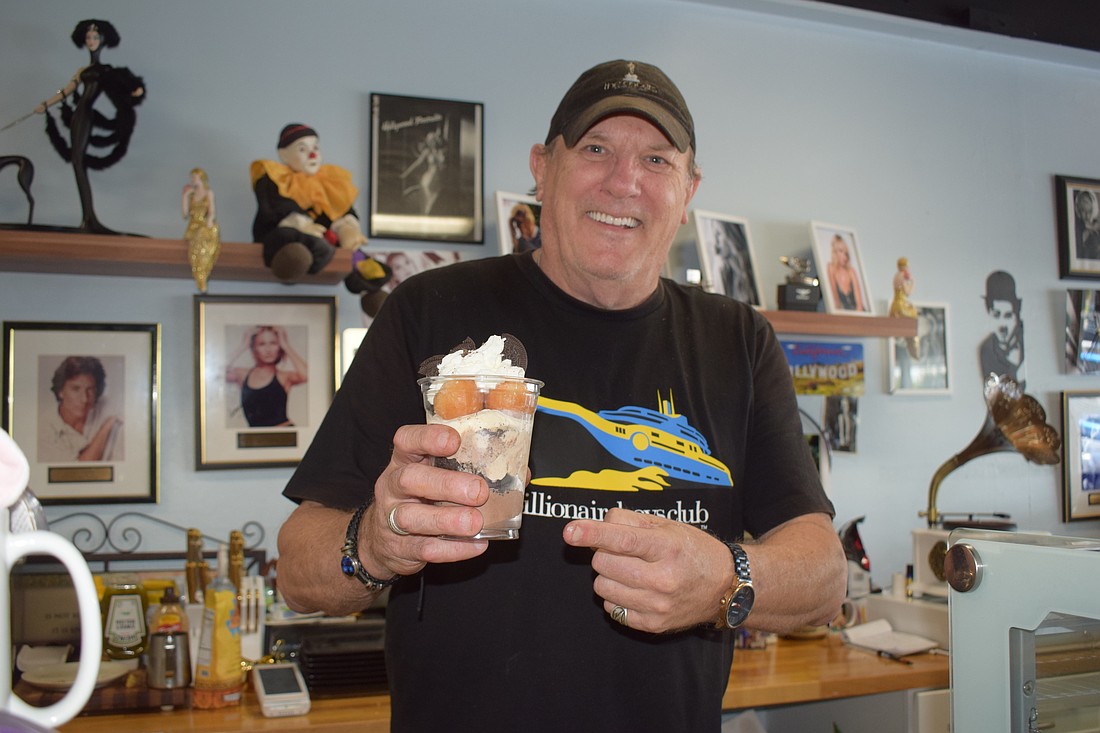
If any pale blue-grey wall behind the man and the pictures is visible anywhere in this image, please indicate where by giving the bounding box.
[0,0,1100,584]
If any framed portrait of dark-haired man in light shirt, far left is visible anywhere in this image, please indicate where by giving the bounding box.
[3,322,161,504]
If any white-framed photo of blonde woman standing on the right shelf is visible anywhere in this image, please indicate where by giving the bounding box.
[810,221,875,316]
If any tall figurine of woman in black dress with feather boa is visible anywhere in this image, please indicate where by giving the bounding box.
[34,20,145,234]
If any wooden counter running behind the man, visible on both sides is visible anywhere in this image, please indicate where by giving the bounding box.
[53,636,950,733]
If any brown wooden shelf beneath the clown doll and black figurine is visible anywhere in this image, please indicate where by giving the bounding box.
[0,229,352,285]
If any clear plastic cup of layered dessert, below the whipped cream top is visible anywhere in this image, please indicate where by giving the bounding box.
[417,374,542,539]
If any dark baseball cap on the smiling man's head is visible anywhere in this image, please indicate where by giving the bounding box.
[547,59,695,153]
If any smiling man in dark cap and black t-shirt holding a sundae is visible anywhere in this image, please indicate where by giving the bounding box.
[279,61,846,732]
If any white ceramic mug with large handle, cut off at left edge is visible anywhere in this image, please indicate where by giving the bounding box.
[0,431,103,727]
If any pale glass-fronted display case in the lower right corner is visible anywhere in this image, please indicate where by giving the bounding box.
[945,529,1100,733]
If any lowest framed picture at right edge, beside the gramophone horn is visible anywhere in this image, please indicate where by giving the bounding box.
[1062,392,1100,522]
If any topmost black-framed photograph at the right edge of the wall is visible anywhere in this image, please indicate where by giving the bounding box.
[1054,176,1100,280]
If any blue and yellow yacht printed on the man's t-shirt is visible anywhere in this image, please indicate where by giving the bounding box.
[538,393,734,488]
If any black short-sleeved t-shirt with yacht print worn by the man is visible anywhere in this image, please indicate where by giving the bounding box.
[284,255,833,732]
